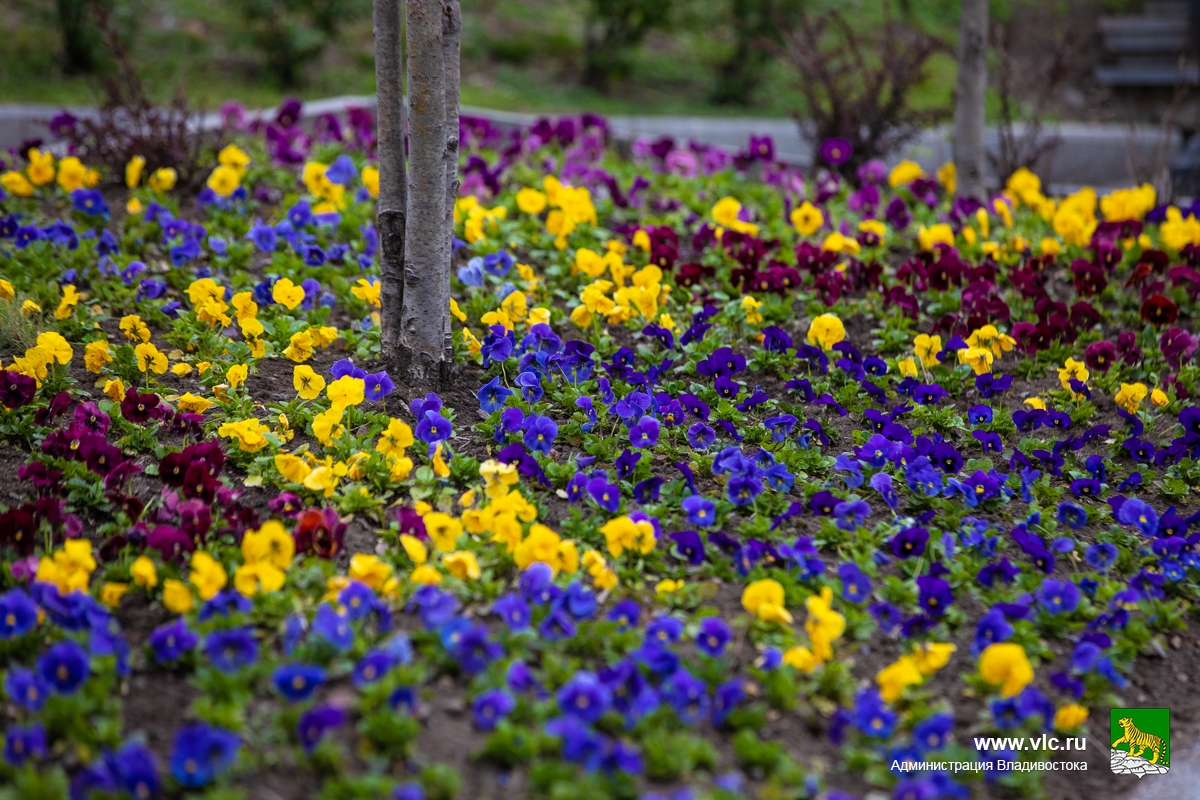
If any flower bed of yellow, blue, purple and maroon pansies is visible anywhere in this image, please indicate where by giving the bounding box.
[0,104,1200,799]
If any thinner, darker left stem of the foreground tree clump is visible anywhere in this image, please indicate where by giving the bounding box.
[374,0,408,365]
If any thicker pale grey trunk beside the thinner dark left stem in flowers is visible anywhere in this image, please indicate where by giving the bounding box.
[397,0,457,386]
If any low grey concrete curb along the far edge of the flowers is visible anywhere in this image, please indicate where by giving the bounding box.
[0,96,1183,192]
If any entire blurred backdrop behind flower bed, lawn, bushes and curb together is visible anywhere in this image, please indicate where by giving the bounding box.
[7,0,1200,193]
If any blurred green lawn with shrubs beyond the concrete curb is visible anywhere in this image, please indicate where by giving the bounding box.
[0,0,1161,120]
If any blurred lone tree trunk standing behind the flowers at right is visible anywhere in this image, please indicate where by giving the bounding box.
[954,0,988,200]
